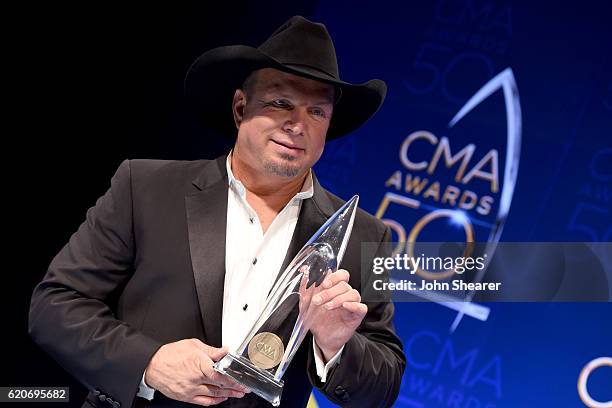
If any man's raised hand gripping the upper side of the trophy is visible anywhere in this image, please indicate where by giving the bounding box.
[308,269,368,361]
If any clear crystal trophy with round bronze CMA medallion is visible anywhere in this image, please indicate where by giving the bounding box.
[214,196,359,407]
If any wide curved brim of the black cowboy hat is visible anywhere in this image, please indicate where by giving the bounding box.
[185,45,387,140]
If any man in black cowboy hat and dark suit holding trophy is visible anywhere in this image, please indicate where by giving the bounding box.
[30,17,405,408]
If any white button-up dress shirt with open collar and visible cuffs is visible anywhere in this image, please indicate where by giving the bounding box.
[137,153,344,400]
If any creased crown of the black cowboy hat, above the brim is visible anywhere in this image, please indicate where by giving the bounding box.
[258,16,340,79]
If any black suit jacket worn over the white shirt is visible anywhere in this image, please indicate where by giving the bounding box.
[29,156,405,408]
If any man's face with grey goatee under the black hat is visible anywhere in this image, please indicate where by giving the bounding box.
[233,68,334,178]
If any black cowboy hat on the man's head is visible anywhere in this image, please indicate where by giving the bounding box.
[185,16,387,140]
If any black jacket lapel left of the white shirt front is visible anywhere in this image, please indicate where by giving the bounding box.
[185,156,228,347]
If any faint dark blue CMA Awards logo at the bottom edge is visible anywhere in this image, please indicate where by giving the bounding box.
[401,330,502,408]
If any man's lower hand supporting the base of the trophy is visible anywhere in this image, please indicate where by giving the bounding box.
[145,339,250,406]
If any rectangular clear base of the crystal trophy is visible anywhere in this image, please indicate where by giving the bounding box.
[213,353,284,407]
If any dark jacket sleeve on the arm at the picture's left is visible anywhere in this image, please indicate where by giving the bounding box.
[29,160,161,408]
